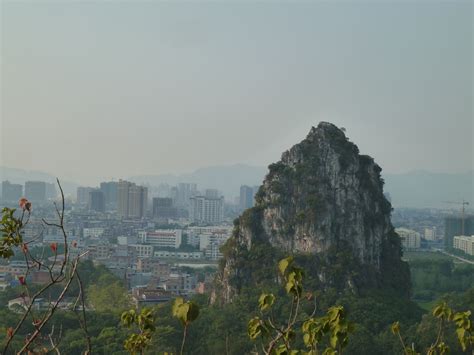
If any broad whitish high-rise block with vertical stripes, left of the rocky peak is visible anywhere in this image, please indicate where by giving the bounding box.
[189,196,224,223]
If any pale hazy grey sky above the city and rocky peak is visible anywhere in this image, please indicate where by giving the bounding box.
[0,0,474,183]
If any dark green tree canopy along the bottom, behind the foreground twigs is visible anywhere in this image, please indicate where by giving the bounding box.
[0,261,474,354]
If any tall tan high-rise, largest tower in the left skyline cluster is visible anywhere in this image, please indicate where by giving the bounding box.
[117,180,148,218]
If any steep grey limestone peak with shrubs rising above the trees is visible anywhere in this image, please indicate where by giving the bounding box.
[216,122,409,302]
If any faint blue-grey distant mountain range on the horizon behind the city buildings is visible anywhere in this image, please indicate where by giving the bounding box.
[0,164,474,208]
